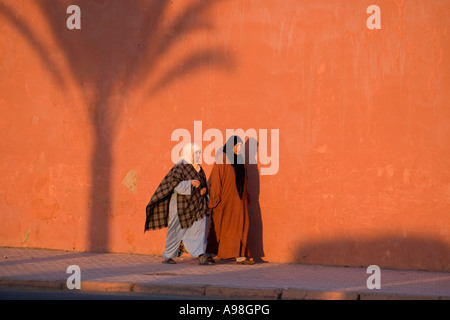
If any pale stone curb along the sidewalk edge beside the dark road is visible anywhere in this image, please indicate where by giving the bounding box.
[0,279,450,300]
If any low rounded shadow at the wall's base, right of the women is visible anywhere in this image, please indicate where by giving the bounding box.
[293,235,450,272]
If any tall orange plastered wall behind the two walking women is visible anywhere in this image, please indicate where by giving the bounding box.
[0,0,450,271]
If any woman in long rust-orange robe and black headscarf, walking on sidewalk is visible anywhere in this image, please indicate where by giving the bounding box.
[206,136,254,264]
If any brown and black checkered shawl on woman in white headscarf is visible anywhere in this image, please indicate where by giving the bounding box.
[144,161,209,232]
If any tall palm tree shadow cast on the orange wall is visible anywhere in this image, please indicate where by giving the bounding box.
[0,0,234,251]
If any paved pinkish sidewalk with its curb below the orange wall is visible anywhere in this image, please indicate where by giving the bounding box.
[0,248,450,300]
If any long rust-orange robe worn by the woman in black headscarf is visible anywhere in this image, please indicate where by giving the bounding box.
[206,154,249,259]
